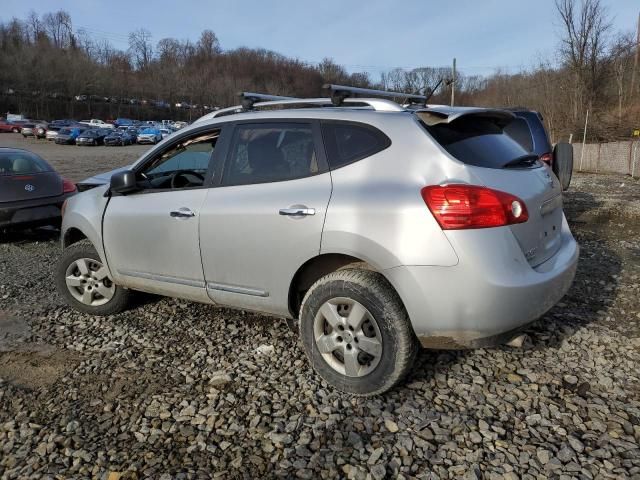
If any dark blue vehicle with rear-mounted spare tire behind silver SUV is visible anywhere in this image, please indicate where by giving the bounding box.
[504,108,573,190]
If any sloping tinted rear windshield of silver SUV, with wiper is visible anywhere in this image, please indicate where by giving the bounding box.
[421,115,538,168]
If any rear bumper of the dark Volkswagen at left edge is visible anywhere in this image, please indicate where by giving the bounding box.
[0,192,75,228]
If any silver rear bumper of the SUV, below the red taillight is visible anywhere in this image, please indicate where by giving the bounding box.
[383,215,579,349]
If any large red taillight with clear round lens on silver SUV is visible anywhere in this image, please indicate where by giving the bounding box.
[420,185,529,230]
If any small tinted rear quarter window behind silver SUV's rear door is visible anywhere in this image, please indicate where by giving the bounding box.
[322,122,391,169]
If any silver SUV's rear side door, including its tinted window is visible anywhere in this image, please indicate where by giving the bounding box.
[200,121,331,316]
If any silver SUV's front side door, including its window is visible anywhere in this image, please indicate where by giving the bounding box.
[103,129,220,301]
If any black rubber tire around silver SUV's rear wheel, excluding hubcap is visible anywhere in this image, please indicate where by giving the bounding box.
[300,268,419,396]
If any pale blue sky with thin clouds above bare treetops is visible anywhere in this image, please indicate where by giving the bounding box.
[0,0,640,78]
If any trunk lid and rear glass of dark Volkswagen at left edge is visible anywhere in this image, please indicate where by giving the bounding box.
[0,150,63,204]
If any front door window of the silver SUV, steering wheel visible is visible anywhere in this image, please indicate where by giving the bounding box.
[138,130,220,189]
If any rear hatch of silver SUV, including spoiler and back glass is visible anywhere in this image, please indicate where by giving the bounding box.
[416,109,563,267]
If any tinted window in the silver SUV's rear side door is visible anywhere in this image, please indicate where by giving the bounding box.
[222,123,319,185]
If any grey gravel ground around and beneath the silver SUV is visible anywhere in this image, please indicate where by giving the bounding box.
[0,137,640,480]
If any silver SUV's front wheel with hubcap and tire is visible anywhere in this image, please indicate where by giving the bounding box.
[55,241,131,316]
